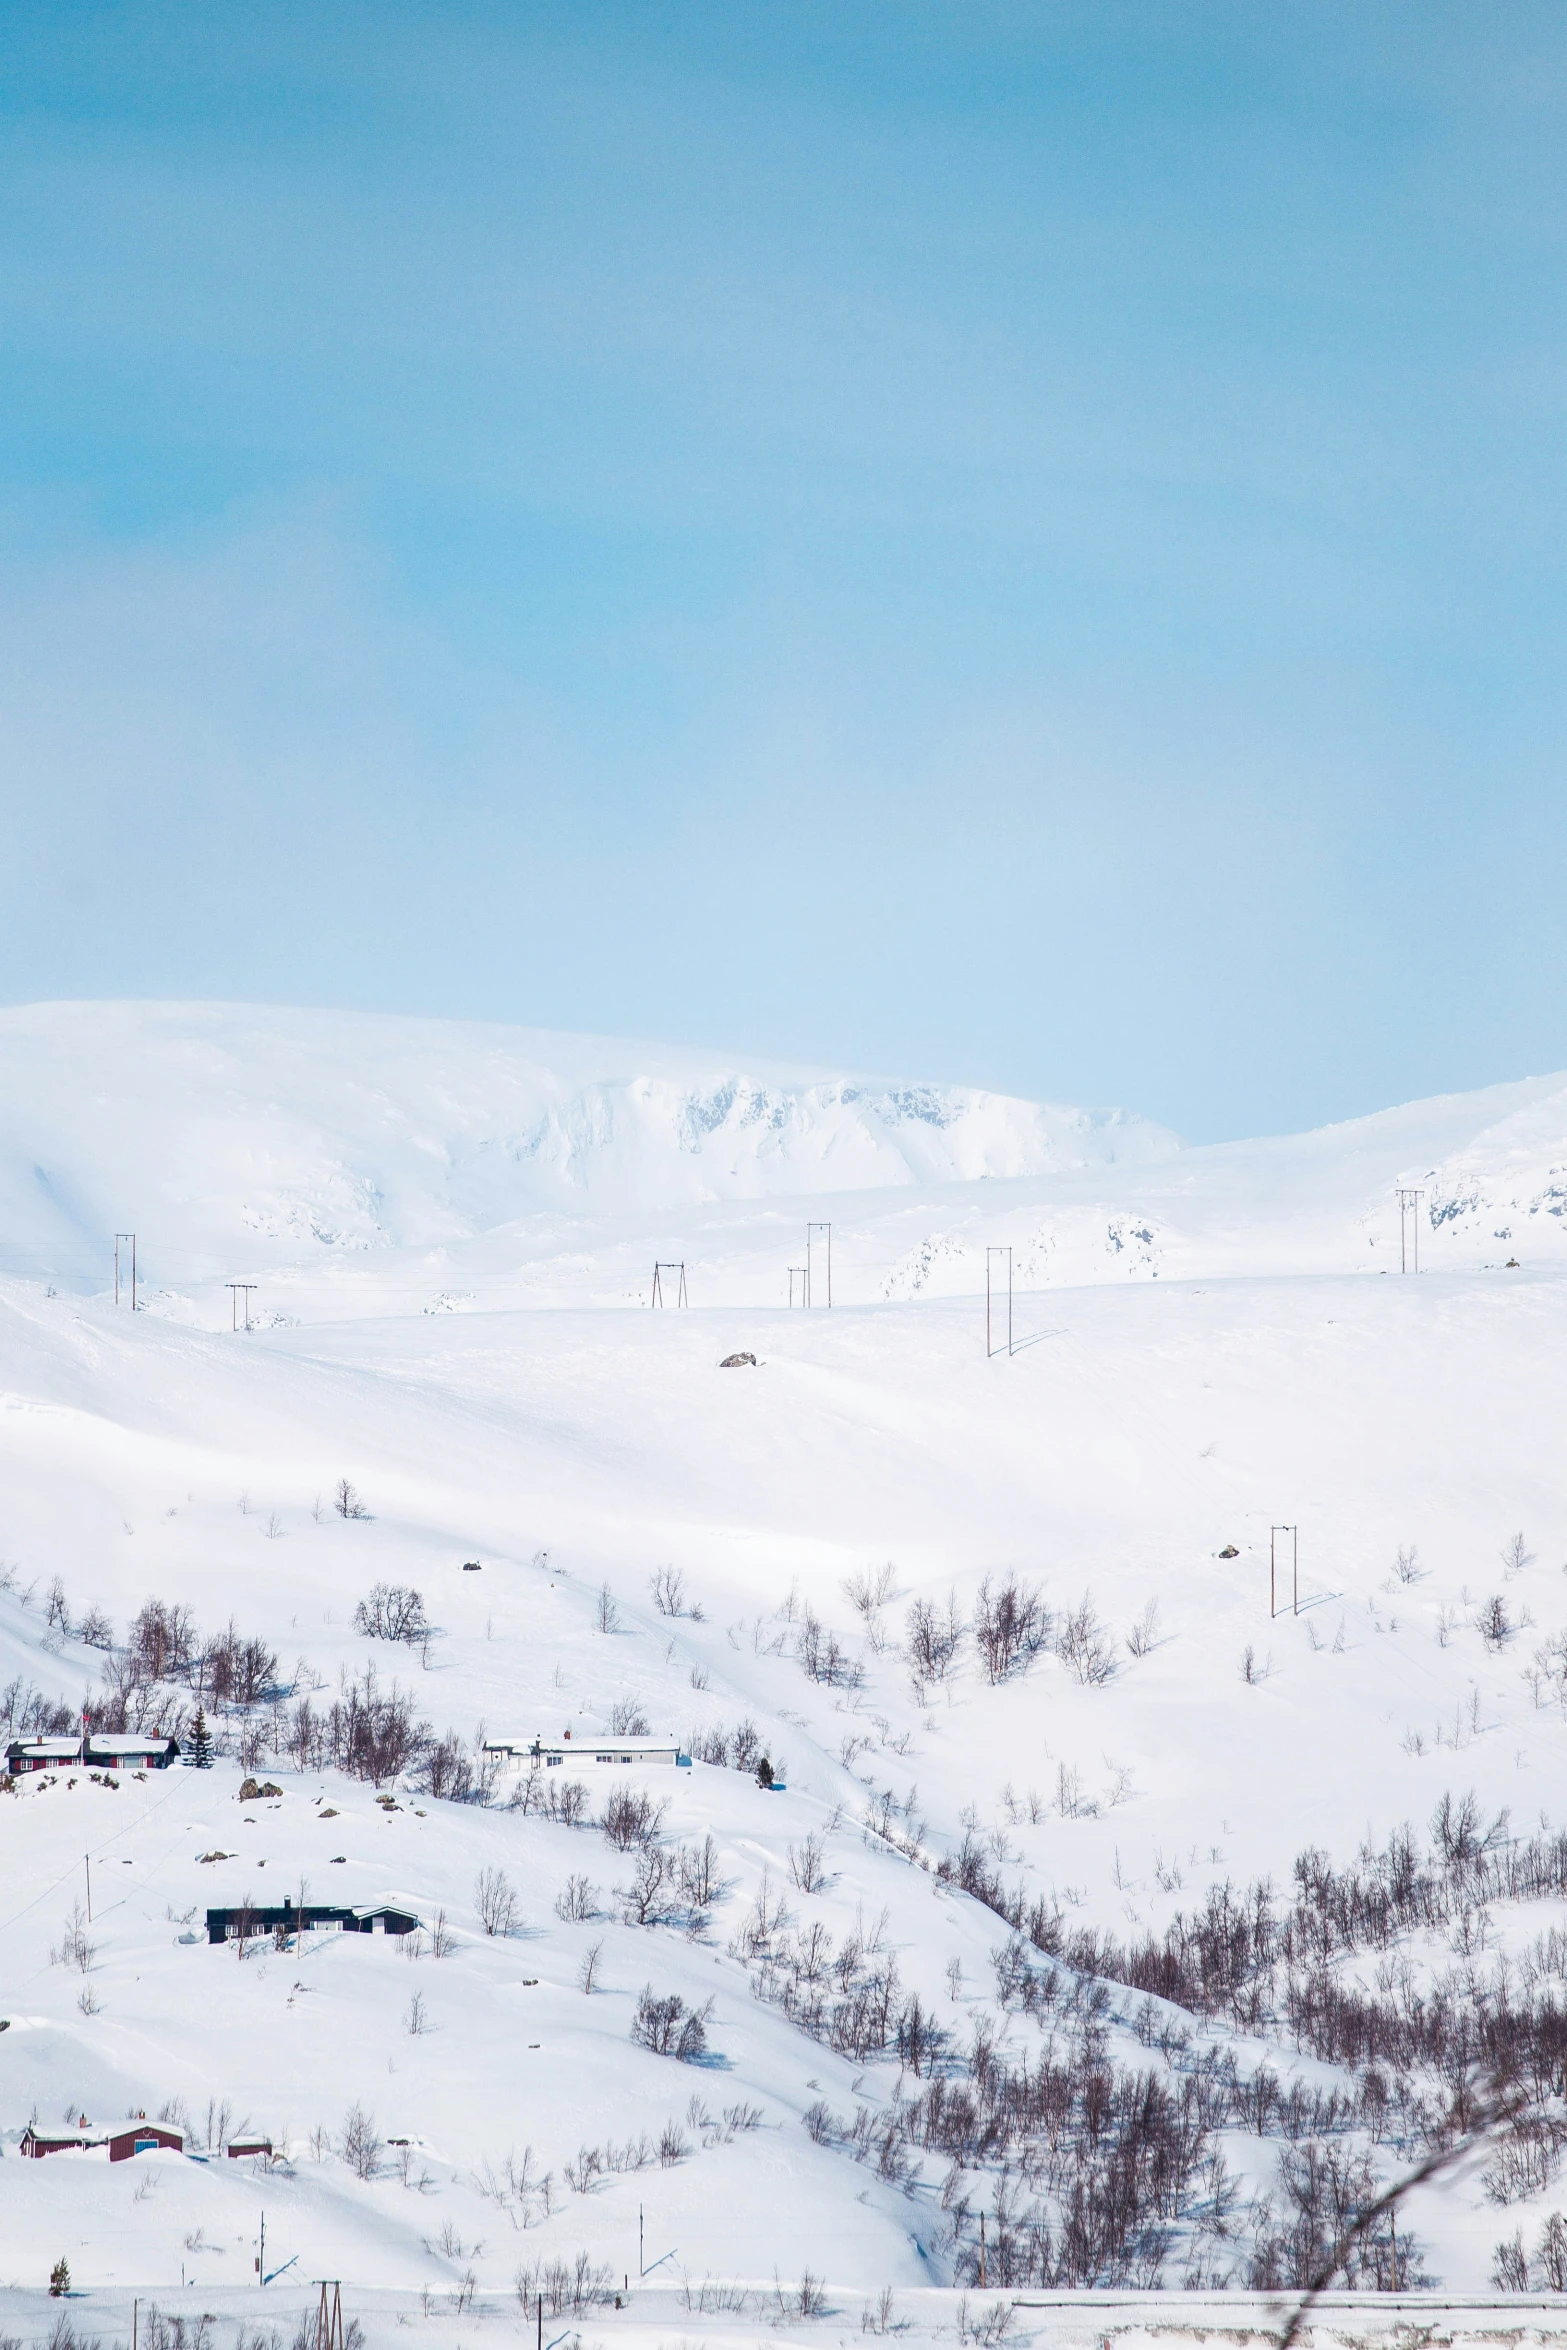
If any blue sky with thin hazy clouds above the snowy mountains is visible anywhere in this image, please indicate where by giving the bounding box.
[0,0,1567,1137]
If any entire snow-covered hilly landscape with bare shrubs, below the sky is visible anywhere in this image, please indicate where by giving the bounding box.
[0,1003,1567,2350]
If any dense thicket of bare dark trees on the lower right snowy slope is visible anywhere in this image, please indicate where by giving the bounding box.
[914,1795,1567,2289]
